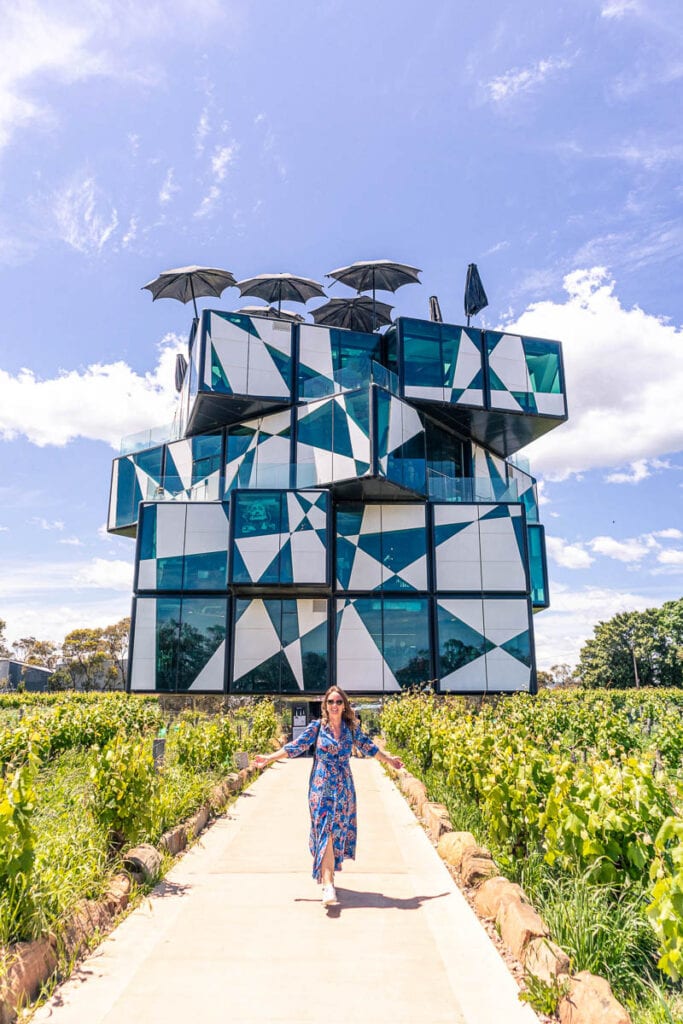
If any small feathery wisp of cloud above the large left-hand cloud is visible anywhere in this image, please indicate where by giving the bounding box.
[52,175,119,256]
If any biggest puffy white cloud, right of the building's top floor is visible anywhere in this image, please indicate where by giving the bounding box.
[505,267,683,480]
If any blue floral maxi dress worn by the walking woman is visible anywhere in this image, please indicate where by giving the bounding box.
[285,719,378,882]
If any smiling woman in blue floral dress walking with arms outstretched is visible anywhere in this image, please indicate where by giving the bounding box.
[255,686,402,906]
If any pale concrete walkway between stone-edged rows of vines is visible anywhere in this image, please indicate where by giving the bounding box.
[34,758,538,1024]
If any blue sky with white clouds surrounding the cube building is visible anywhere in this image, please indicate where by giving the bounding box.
[0,0,683,669]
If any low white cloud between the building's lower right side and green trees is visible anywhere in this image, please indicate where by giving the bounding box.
[533,581,659,669]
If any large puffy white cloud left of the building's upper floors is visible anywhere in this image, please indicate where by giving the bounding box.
[0,334,186,447]
